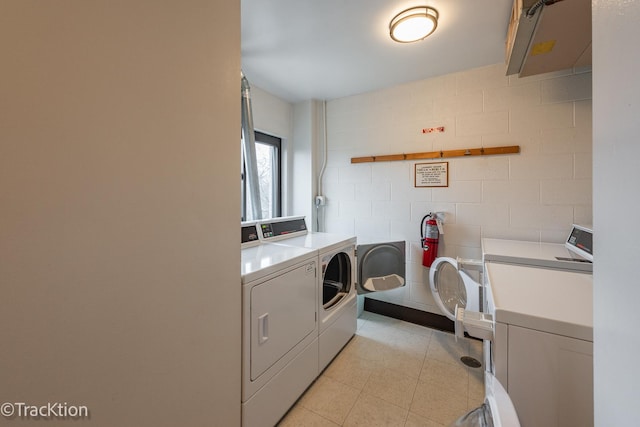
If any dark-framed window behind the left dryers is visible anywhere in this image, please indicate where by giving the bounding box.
[241,132,282,221]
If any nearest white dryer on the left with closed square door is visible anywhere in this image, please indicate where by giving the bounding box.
[241,223,318,427]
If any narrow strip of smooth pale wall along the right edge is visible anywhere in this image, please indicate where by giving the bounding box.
[593,0,640,427]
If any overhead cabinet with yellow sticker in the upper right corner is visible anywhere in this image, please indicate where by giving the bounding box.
[506,0,591,77]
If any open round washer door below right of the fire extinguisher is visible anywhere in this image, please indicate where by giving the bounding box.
[429,257,467,320]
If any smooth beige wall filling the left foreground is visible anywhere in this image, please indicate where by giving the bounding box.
[0,0,241,427]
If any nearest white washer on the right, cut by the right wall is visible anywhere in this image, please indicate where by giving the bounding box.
[484,263,593,427]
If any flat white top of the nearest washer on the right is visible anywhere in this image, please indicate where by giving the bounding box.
[485,263,593,341]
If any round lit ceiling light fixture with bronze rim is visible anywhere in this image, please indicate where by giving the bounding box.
[389,6,438,43]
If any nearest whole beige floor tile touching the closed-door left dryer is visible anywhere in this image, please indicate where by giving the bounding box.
[299,376,360,425]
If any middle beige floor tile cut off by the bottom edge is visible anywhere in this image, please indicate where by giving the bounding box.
[343,394,408,427]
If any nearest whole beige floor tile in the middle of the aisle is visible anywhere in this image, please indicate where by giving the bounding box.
[362,367,418,409]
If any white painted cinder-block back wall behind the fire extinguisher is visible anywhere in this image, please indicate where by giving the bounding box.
[324,64,592,313]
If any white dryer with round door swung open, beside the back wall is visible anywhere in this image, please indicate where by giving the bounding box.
[259,216,405,371]
